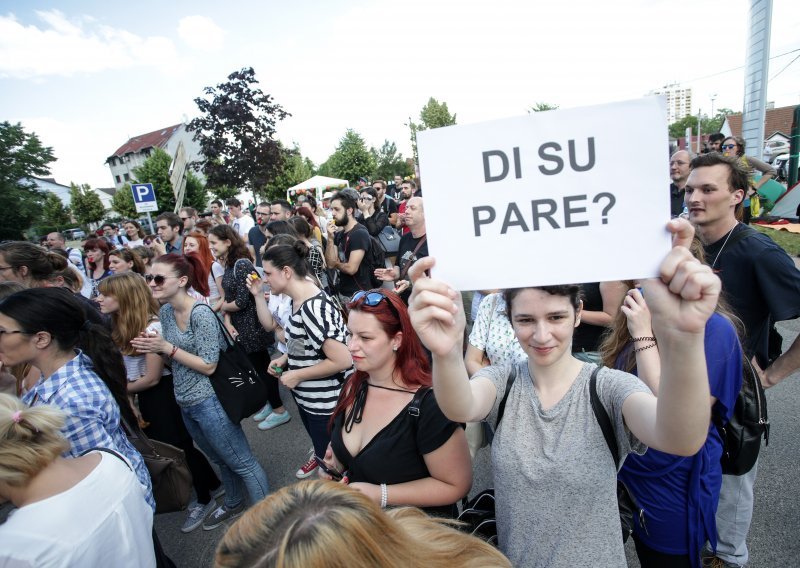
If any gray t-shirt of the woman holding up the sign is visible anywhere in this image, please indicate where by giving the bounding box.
[473,361,650,568]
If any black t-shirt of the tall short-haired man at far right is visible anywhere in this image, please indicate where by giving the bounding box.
[704,223,800,367]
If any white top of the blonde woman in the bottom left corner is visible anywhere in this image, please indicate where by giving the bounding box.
[0,452,156,568]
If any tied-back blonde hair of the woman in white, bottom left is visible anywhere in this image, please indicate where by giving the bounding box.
[0,394,69,487]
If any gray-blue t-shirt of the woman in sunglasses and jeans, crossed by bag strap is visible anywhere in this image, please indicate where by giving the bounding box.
[160,303,225,406]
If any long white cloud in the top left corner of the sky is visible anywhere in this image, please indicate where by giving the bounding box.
[0,10,177,79]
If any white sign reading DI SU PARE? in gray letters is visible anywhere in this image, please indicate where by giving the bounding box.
[417,97,670,290]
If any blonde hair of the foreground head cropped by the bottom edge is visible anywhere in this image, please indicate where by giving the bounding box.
[214,481,511,568]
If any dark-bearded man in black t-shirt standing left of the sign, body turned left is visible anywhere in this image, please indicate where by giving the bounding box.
[325,192,372,304]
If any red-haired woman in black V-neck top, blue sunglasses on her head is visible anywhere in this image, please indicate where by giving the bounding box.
[325,289,472,516]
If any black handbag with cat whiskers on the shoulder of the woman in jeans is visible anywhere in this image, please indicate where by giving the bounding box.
[196,304,267,424]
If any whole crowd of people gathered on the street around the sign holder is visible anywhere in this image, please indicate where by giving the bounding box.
[0,153,800,567]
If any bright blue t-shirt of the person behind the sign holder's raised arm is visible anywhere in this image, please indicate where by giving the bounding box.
[619,314,742,565]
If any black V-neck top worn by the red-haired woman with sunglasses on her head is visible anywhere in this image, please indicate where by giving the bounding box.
[331,391,459,515]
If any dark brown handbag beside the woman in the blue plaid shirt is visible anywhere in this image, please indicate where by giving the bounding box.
[119,417,192,514]
